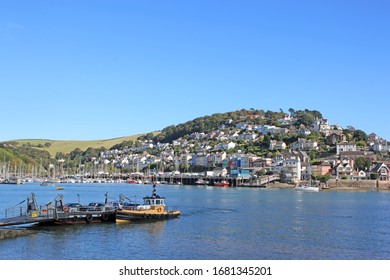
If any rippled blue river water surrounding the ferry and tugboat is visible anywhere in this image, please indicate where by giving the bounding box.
[0,183,390,260]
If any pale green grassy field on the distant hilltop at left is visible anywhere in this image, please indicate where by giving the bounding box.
[14,134,148,156]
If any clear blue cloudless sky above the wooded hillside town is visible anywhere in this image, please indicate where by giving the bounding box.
[0,0,390,141]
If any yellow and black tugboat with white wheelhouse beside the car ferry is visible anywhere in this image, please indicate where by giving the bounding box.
[116,185,180,222]
